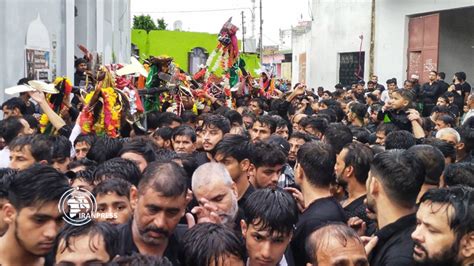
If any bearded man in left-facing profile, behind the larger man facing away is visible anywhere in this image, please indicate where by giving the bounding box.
[334,142,374,229]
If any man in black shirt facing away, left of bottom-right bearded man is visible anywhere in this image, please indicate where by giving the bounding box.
[367,149,425,266]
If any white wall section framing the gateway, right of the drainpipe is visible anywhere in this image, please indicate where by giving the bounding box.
[374,0,474,84]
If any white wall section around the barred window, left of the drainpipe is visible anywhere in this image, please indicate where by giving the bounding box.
[308,0,372,90]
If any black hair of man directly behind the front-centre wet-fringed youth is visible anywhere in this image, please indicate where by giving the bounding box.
[251,142,286,168]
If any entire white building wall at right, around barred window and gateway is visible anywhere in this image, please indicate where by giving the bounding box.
[306,0,474,90]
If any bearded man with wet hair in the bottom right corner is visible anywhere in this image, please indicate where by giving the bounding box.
[411,186,474,266]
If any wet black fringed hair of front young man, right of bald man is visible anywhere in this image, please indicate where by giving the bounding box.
[243,188,299,235]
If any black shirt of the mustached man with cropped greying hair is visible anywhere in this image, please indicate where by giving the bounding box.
[117,219,187,265]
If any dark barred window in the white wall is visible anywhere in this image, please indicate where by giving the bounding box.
[339,52,365,87]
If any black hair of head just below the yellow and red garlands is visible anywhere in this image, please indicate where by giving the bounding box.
[86,137,123,163]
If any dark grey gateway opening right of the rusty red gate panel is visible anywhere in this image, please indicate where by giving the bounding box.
[438,7,474,81]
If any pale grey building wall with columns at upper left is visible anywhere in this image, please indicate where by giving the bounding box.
[0,0,131,105]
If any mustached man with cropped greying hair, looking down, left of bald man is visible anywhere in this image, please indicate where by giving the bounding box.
[118,162,189,265]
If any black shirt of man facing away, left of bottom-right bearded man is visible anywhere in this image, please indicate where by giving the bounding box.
[369,213,416,266]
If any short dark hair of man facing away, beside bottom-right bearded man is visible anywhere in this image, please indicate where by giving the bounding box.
[370,149,425,209]
